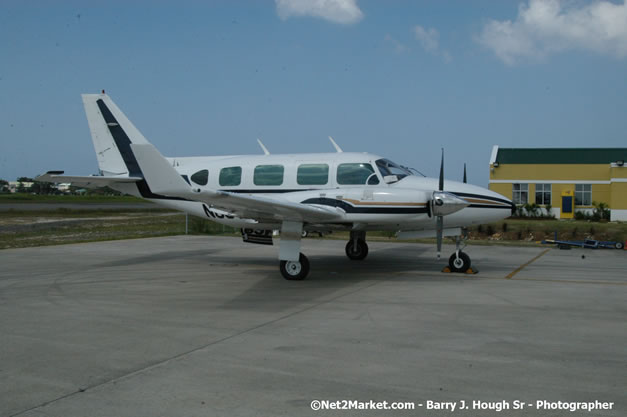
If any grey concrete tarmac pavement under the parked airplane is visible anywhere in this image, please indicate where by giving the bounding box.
[0,236,627,417]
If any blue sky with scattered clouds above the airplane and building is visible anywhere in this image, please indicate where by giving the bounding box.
[0,0,627,185]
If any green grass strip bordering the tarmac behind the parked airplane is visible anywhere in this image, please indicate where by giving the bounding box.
[0,203,627,249]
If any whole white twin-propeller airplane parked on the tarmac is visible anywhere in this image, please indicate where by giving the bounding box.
[37,91,515,280]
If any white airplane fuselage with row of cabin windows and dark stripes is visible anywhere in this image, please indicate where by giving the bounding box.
[111,152,512,231]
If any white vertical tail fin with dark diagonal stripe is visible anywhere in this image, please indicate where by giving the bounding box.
[82,93,149,177]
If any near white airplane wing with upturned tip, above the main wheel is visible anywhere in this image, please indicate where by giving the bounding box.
[130,144,343,222]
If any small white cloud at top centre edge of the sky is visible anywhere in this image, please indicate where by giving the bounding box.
[275,0,364,24]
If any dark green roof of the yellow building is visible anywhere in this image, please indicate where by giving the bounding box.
[496,148,627,164]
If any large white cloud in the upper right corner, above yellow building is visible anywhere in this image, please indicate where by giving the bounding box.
[477,0,627,65]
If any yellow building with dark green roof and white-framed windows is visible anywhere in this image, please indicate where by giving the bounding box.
[490,146,627,221]
